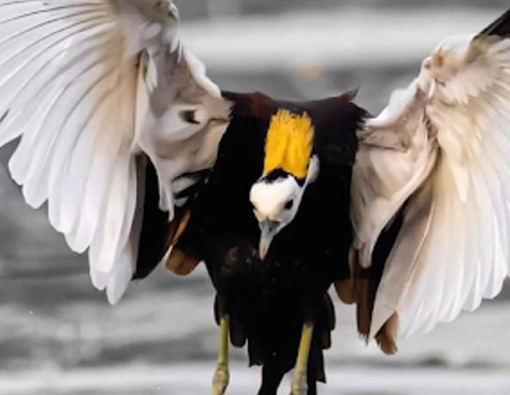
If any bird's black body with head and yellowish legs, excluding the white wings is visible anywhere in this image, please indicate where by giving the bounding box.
[172,92,366,395]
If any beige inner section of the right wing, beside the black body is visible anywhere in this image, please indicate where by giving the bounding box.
[351,83,436,268]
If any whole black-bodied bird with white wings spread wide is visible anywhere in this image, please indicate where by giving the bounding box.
[0,0,510,395]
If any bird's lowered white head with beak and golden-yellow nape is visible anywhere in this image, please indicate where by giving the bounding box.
[250,110,318,259]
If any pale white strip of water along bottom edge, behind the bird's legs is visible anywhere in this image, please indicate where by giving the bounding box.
[0,363,510,395]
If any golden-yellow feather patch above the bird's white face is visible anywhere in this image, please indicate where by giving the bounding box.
[264,110,314,179]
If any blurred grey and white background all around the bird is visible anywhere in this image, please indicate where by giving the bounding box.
[0,0,510,395]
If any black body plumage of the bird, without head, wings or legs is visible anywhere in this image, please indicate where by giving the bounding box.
[159,93,365,395]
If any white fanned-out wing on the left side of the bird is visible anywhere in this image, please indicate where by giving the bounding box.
[0,0,228,303]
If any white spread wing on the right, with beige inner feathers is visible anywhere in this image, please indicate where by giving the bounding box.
[352,6,510,350]
